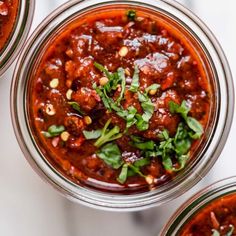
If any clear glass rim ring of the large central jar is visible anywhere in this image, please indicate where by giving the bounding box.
[11,0,234,211]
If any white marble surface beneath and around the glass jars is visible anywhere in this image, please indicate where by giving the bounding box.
[0,0,236,236]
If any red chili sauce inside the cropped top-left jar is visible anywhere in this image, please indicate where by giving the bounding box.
[0,0,19,51]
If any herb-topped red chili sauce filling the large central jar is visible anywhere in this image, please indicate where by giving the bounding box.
[29,10,212,193]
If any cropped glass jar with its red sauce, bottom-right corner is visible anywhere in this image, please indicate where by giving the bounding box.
[161,177,236,236]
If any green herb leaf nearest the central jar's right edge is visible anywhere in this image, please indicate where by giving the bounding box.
[169,100,203,139]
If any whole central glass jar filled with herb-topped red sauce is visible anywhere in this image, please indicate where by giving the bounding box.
[11,1,233,210]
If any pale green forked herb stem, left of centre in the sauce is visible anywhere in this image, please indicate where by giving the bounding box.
[94,119,122,147]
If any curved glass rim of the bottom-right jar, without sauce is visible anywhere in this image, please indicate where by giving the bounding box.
[161,177,236,236]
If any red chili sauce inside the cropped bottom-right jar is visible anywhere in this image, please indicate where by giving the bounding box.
[179,194,236,236]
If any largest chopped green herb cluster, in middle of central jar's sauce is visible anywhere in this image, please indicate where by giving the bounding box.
[93,62,160,131]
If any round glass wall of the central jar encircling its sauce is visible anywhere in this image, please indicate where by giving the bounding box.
[11,0,234,211]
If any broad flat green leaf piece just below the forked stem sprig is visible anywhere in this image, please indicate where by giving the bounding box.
[97,143,123,169]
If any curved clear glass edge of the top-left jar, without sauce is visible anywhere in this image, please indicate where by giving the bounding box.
[0,0,35,76]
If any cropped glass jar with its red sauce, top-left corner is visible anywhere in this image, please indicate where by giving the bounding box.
[0,0,35,76]
